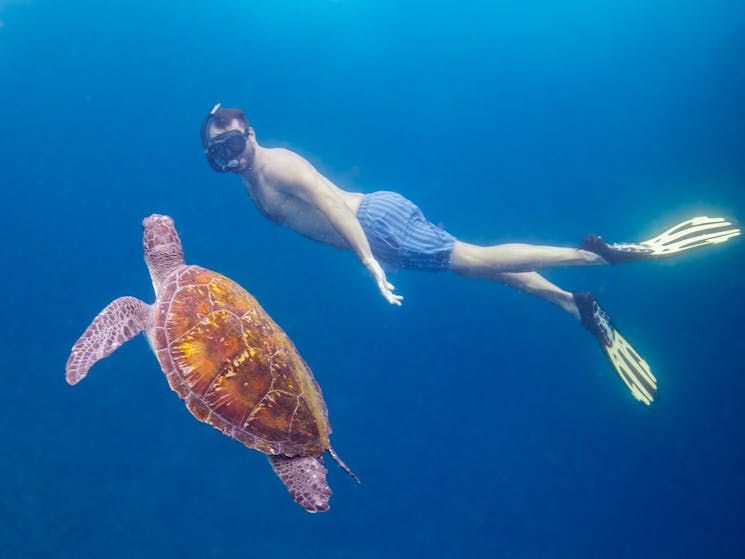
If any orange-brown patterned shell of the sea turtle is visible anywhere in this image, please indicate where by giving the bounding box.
[148,266,331,456]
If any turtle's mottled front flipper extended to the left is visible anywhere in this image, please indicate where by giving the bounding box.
[66,297,150,384]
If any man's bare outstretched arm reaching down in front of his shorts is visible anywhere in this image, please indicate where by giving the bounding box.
[281,156,403,306]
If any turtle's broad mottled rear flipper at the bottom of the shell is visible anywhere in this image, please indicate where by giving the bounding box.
[269,456,331,512]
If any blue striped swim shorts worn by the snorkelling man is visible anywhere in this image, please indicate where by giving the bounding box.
[357,190,455,272]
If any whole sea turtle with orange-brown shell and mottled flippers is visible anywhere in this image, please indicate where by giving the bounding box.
[66,215,356,512]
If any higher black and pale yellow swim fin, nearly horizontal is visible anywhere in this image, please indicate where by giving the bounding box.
[580,216,740,264]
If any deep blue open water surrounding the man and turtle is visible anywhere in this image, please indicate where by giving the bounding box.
[0,0,745,559]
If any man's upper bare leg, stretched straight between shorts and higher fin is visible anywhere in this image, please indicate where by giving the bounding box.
[450,241,608,281]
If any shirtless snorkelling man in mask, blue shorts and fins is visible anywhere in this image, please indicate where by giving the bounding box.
[202,104,740,405]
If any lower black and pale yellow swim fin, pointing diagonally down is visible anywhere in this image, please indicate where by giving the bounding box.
[572,293,657,405]
